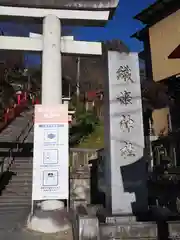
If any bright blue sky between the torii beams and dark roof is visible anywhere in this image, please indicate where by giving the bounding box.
[73,0,155,51]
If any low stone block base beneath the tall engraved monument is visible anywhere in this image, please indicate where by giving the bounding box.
[96,205,158,240]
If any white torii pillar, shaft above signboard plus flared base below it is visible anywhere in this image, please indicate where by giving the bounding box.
[27,15,70,233]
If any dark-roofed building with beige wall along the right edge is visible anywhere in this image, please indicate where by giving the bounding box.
[132,0,180,165]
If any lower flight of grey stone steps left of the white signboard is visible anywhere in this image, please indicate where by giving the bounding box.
[0,158,32,230]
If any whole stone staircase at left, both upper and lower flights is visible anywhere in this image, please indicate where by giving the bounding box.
[0,109,33,231]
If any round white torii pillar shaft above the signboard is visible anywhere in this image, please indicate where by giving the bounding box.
[42,15,62,105]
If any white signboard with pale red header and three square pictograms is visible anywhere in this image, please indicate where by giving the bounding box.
[32,104,69,201]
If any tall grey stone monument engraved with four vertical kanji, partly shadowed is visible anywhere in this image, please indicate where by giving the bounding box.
[105,51,148,215]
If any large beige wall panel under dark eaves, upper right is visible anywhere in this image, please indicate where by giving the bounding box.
[149,10,180,82]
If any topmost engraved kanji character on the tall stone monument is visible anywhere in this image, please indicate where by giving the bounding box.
[116,65,134,83]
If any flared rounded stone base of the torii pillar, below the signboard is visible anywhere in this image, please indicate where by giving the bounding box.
[27,200,71,233]
